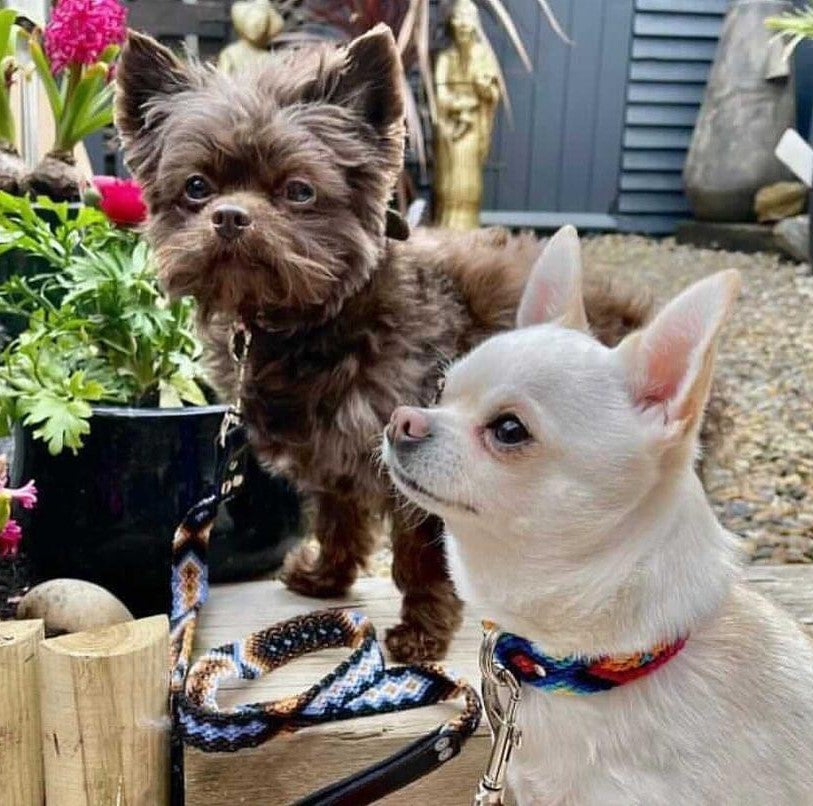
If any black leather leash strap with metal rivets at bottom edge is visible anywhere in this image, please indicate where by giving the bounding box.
[294,726,462,806]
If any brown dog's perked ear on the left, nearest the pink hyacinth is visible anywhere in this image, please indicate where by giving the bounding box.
[116,31,191,180]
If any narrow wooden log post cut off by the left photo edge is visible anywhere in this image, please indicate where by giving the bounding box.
[0,619,44,806]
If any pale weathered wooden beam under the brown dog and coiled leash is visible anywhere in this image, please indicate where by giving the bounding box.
[185,565,813,806]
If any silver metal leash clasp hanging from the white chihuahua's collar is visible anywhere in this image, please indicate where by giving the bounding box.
[473,621,522,806]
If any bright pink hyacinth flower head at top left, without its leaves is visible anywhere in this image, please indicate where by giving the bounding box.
[45,0,127,75]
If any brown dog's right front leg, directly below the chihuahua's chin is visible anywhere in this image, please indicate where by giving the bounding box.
[386,510,463,663]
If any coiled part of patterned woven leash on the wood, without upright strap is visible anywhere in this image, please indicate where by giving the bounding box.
[176,610,480,751]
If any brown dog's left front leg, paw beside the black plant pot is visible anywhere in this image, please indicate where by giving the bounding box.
[282,493,374,598]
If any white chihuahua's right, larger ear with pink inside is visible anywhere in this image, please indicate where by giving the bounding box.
[616,269,740,436]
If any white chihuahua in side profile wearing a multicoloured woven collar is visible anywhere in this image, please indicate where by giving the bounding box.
[384,227,813,806]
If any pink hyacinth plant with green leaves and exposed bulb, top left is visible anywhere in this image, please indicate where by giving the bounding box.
[19,0,127,202]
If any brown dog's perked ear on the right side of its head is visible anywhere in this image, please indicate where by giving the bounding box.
[312,23,404,134]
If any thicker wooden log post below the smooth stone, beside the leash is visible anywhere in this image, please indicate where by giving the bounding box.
[39,616,170,806]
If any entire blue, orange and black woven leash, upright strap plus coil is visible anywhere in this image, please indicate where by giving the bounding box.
[170,422,481,751]
